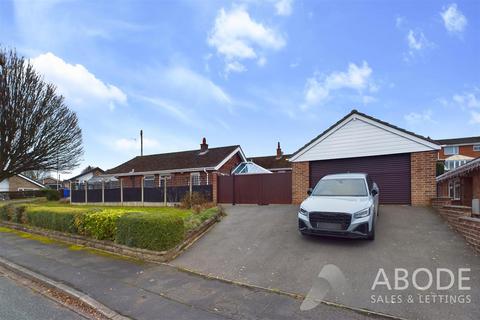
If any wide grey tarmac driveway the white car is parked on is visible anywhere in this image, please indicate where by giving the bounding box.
[173,205,480,319]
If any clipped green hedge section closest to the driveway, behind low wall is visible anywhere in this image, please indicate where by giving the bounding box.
[115,213,185,251]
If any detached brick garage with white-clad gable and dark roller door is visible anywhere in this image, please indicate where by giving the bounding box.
[290,110,440,205]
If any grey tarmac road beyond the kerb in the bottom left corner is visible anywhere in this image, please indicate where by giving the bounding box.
[0,272,85,320]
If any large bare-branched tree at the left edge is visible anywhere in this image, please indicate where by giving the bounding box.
[0,48,83,181]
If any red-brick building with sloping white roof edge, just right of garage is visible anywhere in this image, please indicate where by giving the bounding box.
[437,158,480,208]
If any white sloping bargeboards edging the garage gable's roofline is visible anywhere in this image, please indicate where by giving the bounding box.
[289,114,441,162]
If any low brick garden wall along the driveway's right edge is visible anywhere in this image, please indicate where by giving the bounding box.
[438,206,480,252]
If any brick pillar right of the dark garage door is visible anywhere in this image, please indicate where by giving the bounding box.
[410,151,437,206]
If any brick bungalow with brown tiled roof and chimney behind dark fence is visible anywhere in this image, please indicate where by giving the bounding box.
[104,138,246,202]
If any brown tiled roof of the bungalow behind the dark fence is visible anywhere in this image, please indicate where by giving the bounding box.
[106,145,240,174]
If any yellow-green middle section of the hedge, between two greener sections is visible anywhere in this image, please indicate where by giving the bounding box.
[76,209,126,241]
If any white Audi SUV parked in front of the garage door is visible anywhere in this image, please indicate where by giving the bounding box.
[298,173,379,240]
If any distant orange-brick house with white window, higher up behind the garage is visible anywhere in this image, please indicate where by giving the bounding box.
[436,137,480,171]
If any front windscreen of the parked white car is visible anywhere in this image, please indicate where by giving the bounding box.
[312,179,368,197]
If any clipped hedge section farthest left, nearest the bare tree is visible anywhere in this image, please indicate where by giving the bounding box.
[25,206,85,233]
